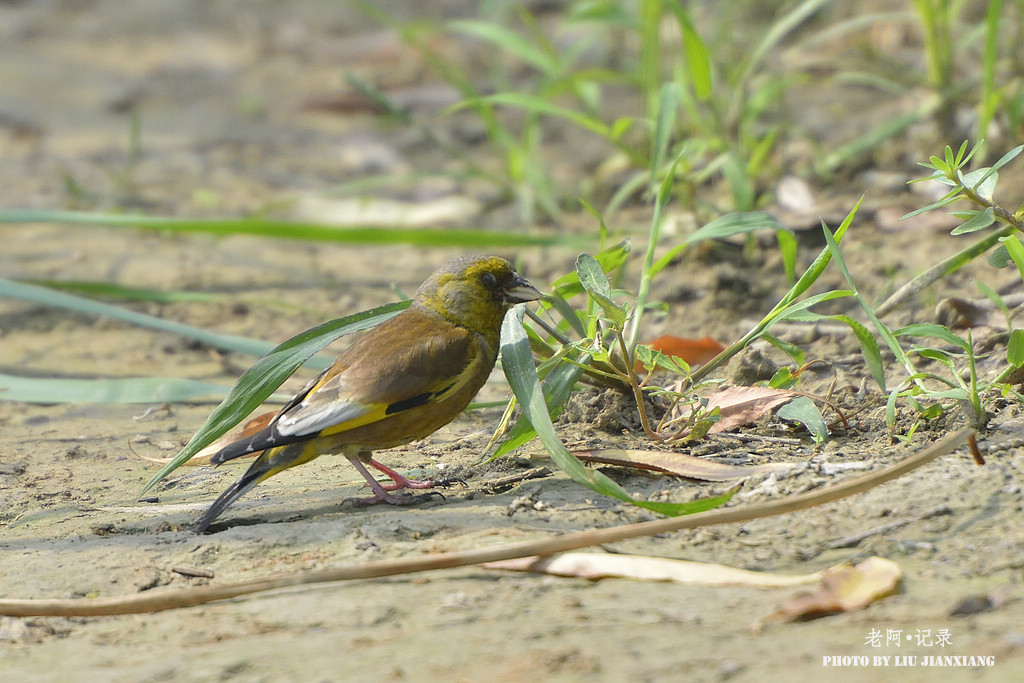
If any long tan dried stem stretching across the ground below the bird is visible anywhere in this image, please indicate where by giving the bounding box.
[0,429,973,616]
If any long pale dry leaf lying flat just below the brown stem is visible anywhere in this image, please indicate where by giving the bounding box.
[481,553,824,588]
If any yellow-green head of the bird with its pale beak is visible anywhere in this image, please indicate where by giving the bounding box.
[416,256,541,344]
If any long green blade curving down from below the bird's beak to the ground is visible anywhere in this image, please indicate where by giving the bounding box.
[502,304,733,515]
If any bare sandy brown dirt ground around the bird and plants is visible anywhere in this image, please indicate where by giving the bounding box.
[0,0,1024,682]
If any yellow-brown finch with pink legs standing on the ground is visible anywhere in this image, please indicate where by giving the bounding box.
[193,256,542,533]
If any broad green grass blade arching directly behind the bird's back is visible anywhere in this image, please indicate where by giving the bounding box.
[139,301,412,496]
